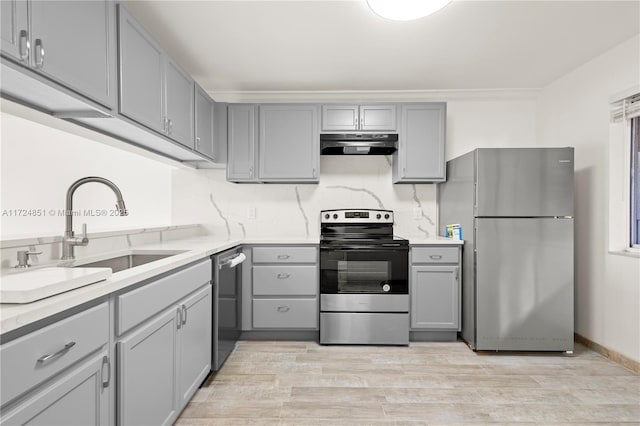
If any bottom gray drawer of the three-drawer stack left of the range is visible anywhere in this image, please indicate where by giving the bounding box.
[253,298,318,329]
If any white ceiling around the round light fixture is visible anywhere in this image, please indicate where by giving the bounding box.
[125,0,640,94]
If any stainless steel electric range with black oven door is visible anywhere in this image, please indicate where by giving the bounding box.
[320,209,409,345]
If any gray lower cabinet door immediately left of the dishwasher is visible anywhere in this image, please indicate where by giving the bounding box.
[178,285,212,407]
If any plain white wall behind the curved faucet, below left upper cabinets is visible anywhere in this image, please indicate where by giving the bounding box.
[0,106,174,240]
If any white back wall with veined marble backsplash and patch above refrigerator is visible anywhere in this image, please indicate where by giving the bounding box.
[173,98,536,240]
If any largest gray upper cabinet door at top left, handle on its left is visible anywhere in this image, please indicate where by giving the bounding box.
[30,0,116,108]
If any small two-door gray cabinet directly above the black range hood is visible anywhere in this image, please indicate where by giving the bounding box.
[322,104,397,132]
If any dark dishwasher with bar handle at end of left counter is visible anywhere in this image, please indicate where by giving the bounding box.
[211,248,246,371]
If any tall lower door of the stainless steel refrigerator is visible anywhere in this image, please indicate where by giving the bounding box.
[476,219,573,351]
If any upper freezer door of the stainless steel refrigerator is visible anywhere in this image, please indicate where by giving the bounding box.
[475,148,573,217]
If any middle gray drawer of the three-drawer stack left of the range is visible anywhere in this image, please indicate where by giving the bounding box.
[253,265,318,296]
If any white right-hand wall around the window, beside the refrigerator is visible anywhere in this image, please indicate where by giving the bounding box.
[537,36,640,361]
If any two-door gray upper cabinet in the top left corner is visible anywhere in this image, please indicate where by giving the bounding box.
[0,0,117,109]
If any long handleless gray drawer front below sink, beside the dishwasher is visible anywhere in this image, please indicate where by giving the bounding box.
[116,260,211,336]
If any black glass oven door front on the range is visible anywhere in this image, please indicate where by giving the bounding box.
[320,245,409,294]
